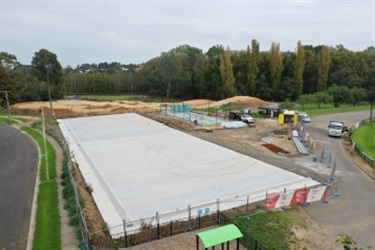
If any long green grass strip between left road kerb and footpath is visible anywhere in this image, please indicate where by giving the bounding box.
[21,127,61,249]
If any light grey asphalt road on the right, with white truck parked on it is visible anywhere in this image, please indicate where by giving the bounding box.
[306,111,375,247]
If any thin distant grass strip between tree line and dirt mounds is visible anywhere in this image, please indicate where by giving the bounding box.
[80,95,162,102]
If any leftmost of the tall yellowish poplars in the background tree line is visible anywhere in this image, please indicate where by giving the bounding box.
[220,48,236,98]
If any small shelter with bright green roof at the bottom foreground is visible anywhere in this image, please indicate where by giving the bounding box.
[197,224,243,249]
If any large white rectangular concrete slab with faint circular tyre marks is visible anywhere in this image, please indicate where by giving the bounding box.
[59,114,319,233]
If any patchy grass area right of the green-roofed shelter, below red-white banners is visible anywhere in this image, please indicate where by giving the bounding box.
[230,208,306,249]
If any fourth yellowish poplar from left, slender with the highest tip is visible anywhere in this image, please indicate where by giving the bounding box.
[293,41,306,99]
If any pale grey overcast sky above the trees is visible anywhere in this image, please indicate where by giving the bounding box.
[0,0,375,68]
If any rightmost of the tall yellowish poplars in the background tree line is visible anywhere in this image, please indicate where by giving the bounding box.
[316,46,331,91]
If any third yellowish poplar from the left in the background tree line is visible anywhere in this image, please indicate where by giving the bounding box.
[270,43,283,101]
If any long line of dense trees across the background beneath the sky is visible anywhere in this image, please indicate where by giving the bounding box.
[0,39,375,106]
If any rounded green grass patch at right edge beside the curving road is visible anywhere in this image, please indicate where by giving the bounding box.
[353,122,375,160]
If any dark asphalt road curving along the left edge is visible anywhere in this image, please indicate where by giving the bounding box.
[0,123,38,249]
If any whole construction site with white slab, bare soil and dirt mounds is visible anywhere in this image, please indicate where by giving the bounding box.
[12,97,340,248]
